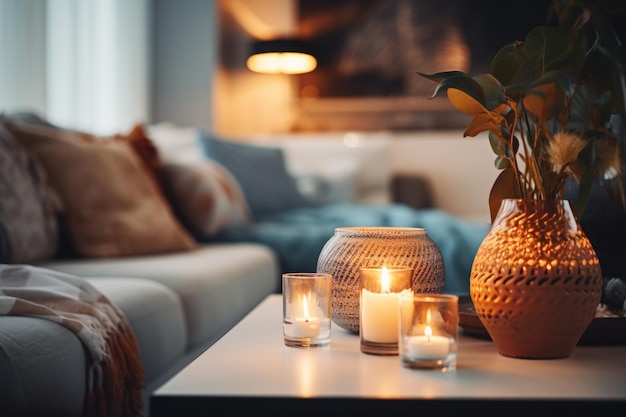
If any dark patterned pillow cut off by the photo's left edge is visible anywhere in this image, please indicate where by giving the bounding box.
[0,119,59,263]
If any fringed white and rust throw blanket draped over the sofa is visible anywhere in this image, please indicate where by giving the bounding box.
[0,264,144,417]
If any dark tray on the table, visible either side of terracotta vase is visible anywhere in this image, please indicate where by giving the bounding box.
[459,296,626,346]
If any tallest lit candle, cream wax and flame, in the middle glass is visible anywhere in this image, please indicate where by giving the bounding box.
[361,267,410,343]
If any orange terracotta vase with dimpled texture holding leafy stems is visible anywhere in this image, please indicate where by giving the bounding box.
[470,199,602,359]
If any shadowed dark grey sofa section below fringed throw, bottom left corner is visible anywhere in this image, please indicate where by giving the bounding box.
[0,316,88,417]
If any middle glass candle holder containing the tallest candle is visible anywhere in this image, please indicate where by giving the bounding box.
[359,266,413,355]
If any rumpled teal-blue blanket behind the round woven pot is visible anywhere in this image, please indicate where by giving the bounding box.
[216,203,489,294]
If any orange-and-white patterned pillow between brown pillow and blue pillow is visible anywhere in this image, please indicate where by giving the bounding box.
[159,161,250,238]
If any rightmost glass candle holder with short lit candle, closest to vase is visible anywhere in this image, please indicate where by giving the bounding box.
[399,294,459,372]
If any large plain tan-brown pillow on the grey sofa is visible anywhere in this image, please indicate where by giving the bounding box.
[5,118,195,257]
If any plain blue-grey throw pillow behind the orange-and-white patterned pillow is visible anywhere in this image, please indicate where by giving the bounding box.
[198,131,312,217]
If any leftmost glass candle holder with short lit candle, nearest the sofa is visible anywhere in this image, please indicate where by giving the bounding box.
[282,272,332,347]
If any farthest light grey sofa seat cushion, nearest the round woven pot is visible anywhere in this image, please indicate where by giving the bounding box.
[39,243,281,350]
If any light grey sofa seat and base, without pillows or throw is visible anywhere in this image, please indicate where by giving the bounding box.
[0,243,280,417]
